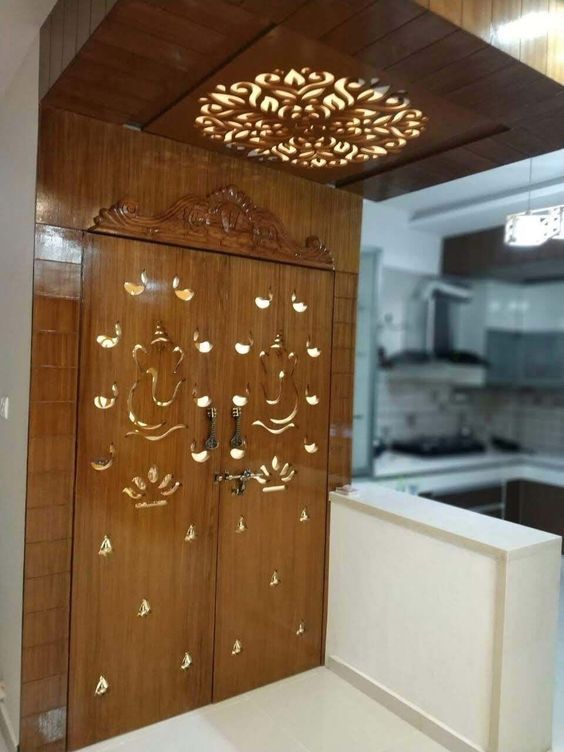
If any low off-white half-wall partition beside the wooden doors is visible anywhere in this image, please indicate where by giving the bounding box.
[326,482,560,752]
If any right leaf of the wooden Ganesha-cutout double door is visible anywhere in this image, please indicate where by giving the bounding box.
[214,260,333,700]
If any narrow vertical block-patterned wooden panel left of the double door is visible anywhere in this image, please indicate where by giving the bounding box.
[20,225,82,752]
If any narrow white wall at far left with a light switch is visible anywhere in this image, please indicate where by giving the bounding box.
[0,39,39,748]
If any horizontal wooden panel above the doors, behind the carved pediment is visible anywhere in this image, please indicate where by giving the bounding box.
[37,107,362,276]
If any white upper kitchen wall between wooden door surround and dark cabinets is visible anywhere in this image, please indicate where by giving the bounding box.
[361,201,442,274]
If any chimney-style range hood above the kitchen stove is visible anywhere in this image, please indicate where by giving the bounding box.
[381,277,487,386]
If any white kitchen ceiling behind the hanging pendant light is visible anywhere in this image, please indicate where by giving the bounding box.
[380,149,564,237]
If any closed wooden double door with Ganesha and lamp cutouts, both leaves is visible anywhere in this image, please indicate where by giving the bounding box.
[69,236,333,749]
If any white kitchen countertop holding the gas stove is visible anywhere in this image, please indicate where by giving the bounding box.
[364,450,564,494]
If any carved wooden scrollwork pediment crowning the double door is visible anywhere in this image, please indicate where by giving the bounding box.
[90,185,333,269]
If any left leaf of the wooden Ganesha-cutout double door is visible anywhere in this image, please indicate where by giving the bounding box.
[69,237,228,748]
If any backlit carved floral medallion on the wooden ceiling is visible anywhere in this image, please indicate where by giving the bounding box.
[195,68,428,168]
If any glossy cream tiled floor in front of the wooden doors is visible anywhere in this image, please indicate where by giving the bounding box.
[77,668,445,752]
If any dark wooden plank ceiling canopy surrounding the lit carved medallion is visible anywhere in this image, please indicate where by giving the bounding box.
[41,0,564,200]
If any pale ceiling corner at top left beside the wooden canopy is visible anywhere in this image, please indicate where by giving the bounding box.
[0,0,56,97]
